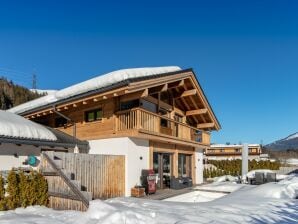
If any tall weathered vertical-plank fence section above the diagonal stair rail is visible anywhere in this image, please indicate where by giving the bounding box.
[55,152,125,199]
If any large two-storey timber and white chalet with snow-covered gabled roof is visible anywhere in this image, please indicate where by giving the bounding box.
[10,66,221,196]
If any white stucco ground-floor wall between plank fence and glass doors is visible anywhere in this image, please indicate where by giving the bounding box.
[89,137,149,196]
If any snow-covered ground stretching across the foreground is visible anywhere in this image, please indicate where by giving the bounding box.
[0,175,298,224]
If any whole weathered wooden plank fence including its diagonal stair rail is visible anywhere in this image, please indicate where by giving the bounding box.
[40,152,125,211]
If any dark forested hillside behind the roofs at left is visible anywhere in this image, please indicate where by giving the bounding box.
[0,77,43,110]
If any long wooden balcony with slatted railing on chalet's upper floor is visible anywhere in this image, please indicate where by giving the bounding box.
[115,108,210,146]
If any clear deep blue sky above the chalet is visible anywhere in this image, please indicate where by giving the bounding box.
[0,0,298,143]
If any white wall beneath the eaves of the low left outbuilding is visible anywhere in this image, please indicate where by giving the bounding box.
[0,143,40,171]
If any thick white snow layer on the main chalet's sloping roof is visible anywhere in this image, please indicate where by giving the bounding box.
[9,66,181,114]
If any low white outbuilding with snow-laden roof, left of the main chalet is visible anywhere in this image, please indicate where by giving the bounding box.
[0,110,88,171]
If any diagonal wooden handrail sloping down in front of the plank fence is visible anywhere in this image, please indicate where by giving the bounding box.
[42,152,89,208]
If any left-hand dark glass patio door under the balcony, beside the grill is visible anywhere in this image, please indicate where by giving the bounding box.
[153,152,172,189]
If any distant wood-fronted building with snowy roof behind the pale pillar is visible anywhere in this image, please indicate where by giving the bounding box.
[204,144,262,160]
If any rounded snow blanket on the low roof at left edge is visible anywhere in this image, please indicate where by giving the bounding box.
[0,110,57,141]
